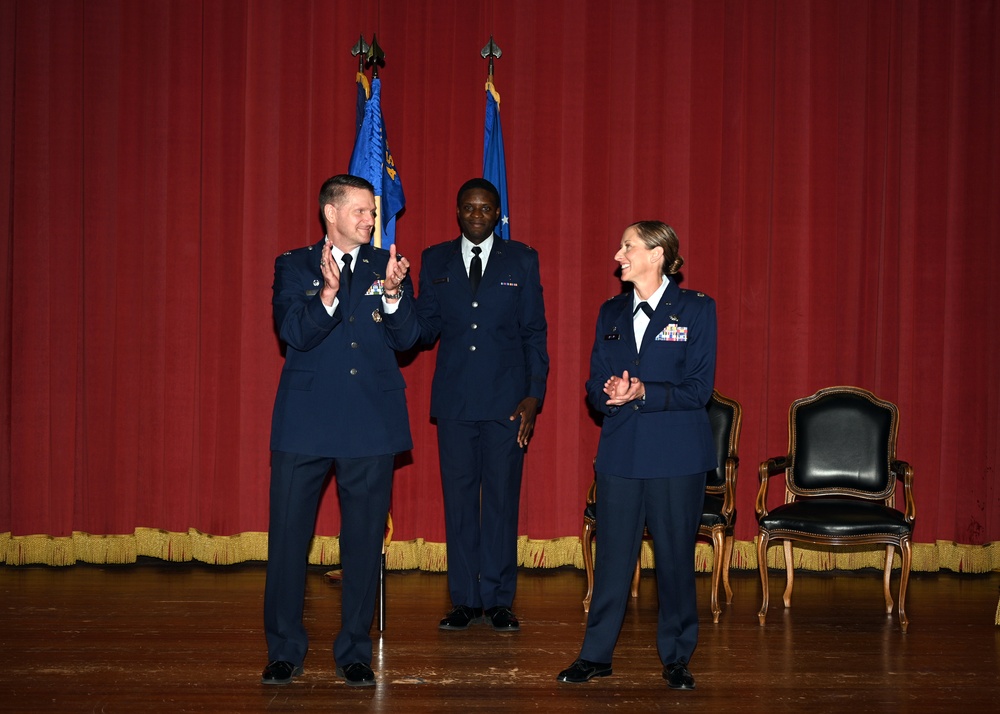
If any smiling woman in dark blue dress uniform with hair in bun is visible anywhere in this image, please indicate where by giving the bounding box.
[558,221,717,689]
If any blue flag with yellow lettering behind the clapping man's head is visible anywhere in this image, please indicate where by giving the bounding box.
[347,72,406,248]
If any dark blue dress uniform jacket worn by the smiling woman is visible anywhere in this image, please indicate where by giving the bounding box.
[587,280,717,478]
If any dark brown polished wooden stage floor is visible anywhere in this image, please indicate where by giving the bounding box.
[0,561,1000,714]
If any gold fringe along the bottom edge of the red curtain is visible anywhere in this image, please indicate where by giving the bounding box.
[0,528,1000,572]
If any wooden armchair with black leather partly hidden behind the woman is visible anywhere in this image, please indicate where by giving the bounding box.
[580,390,743,622]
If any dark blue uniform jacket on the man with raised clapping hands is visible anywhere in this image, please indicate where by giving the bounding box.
[271,236,420,458]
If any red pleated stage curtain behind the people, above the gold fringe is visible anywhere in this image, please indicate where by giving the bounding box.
[0,0,1000,544]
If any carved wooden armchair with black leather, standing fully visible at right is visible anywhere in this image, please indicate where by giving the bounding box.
[755,386,916,632]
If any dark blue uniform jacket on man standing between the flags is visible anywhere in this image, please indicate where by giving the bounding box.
[417,238,549,421]
